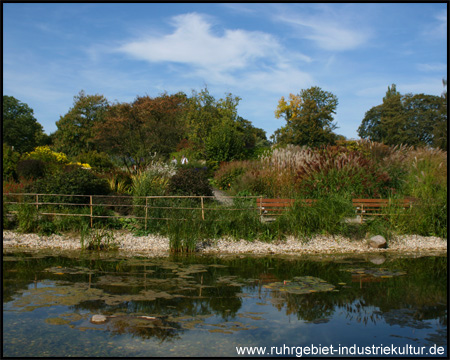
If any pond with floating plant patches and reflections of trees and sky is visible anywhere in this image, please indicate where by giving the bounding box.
[3,250,447,357]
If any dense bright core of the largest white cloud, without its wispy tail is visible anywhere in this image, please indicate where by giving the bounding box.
[118,13,280,71]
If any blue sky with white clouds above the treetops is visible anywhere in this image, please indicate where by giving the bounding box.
[2,3,447,139]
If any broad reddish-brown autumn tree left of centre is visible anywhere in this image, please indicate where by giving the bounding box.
[94,93,186,171]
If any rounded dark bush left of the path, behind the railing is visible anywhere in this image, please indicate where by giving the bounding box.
[168,168,213,196]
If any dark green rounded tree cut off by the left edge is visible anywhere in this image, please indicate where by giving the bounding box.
[3,95,46,153]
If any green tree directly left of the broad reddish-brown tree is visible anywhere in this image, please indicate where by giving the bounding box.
[53,90,109,156]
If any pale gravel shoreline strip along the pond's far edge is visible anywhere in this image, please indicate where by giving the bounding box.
[3,231,447,256]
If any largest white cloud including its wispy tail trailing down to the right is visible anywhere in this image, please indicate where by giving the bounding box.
[116,13,313,93]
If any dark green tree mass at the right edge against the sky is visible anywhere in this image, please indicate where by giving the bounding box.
[358,84,447,146]
